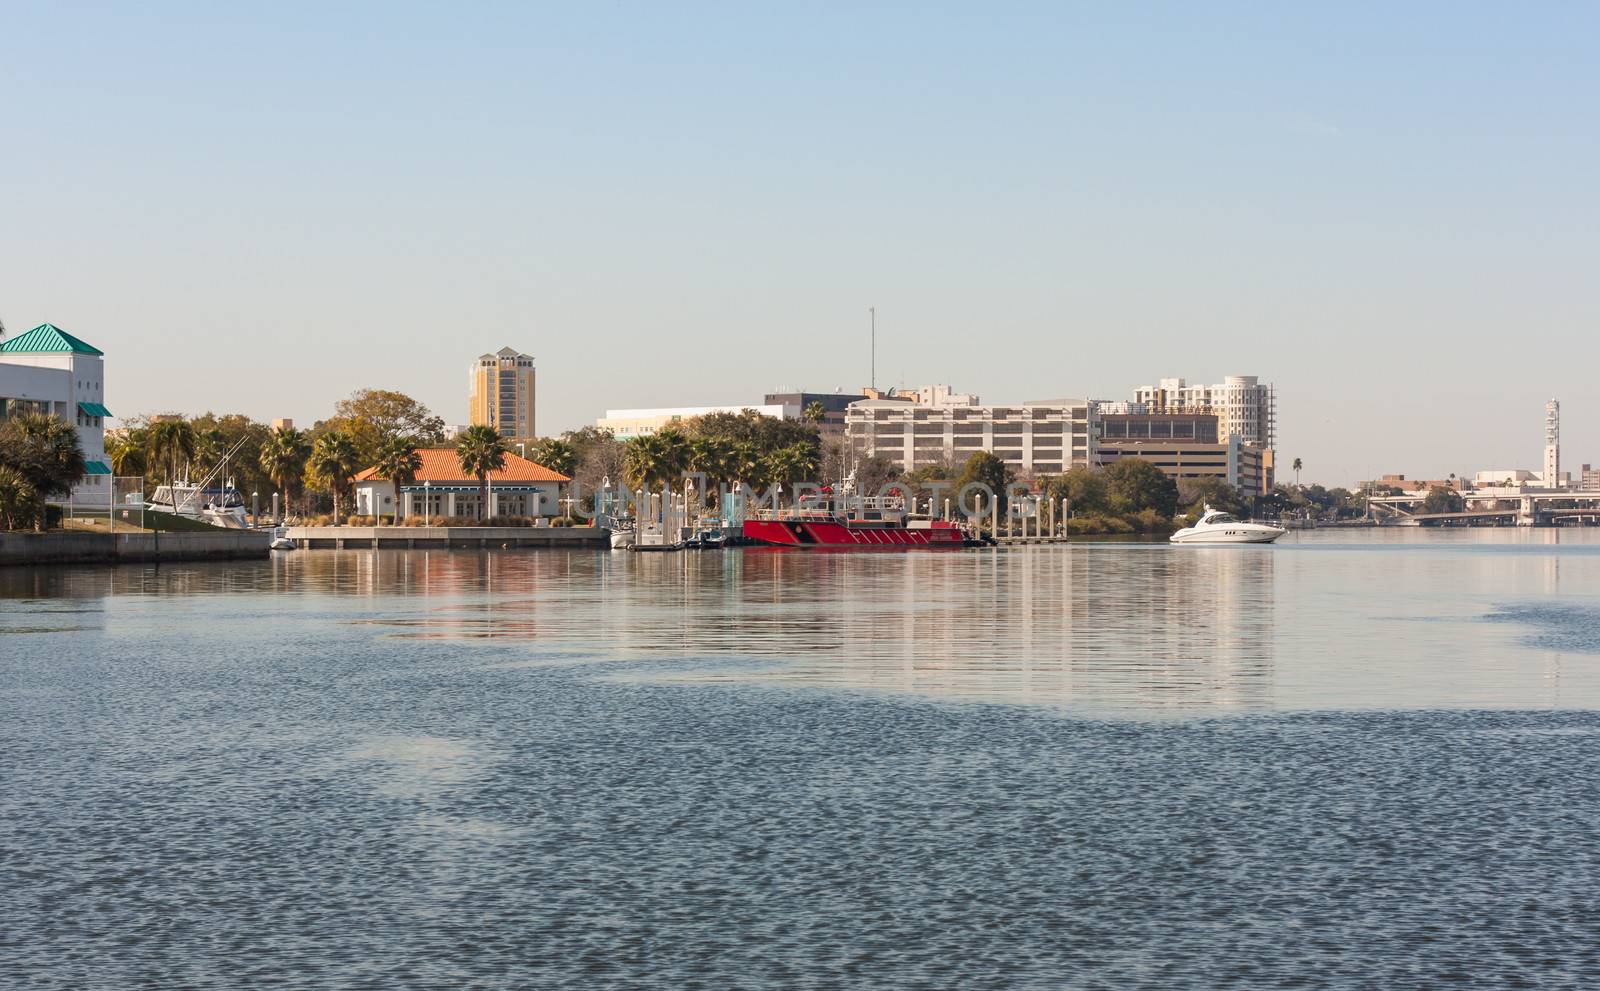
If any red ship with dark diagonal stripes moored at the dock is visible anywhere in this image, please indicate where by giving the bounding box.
[744,480,976,551]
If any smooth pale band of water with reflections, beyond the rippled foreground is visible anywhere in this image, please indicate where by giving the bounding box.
[9,530,1600,711]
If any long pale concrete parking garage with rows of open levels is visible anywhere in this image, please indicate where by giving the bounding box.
[845,399,1099,479]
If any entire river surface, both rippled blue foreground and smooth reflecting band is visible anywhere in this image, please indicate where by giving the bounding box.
[0,530,1600,989]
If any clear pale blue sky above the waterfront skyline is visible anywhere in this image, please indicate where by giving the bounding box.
[0,0,1600,485]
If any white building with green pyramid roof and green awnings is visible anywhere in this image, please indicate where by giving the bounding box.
[0,323,112,504]
